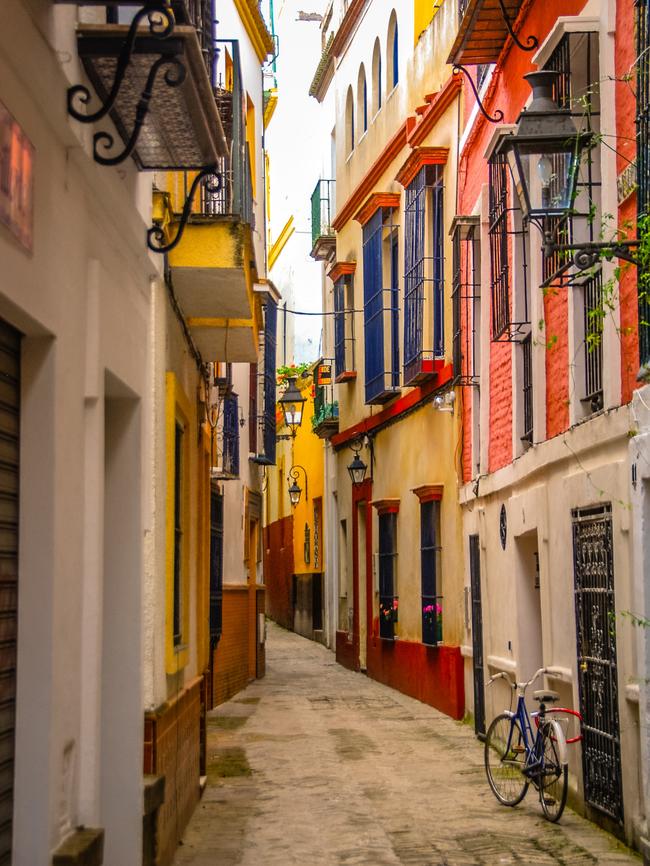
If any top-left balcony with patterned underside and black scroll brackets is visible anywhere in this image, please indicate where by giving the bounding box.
[65,0,228,171]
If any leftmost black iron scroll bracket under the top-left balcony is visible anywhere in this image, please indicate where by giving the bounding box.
[68,0,180,125]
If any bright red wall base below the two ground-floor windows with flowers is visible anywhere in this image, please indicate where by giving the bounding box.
[368,638,465,719]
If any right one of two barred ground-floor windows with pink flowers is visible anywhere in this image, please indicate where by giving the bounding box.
[420,499,442,646]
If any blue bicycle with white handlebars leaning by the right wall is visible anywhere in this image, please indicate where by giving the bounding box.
[485,668,569,823]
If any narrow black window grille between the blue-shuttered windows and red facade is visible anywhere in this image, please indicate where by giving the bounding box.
[451,216,481,385]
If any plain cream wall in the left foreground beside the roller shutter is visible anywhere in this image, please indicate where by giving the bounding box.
[0,0,155,866]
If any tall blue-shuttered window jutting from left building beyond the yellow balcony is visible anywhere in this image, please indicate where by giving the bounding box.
[251,295,278,466]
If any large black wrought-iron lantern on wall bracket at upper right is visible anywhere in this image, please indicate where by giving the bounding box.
[498,70,638,270]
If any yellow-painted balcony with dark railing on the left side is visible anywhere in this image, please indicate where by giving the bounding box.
[154,41,264,363]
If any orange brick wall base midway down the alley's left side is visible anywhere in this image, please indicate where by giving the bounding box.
[212,585,249,706]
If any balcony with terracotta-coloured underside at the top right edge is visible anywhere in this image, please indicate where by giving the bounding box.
[447,0,532,66]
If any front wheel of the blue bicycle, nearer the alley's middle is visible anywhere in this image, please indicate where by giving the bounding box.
[485,713,528,806]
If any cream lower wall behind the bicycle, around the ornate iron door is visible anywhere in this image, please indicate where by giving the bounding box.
[461,407,642,831]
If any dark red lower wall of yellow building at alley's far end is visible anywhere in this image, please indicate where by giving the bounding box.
[264,516,294,629]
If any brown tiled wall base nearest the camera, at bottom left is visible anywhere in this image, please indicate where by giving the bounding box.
[144,677,201,866]
